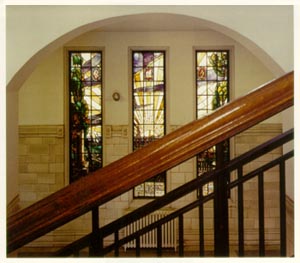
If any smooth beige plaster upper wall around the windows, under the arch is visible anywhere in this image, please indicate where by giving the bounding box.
[19,31,274,125]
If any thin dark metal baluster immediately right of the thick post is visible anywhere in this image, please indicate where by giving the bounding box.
[238,166,245,257]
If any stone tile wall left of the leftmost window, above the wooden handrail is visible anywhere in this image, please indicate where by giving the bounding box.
[19,125,65,208]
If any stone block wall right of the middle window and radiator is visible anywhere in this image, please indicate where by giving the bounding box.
[164,123,292,254]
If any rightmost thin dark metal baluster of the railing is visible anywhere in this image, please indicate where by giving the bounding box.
[279,161,287,257]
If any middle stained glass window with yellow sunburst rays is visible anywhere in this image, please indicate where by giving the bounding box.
[132,51,166,198]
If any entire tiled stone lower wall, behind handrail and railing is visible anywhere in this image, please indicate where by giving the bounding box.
[19,124,292,256]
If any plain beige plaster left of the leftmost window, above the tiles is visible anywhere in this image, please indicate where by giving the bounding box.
[19,49,64,125]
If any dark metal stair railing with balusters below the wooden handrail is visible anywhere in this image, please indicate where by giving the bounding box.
[53,130,294,257]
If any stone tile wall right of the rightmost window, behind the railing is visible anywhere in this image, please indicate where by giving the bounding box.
[232,124,282,254]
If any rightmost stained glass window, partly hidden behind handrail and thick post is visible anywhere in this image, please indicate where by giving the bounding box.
[196,50,229,196]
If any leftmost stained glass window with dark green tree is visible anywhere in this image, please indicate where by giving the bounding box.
[69,51,102,183]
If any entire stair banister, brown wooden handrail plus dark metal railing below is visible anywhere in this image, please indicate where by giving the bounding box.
[7,73,293,257]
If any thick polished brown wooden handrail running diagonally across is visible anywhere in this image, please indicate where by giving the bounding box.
[7,72,294,253]
